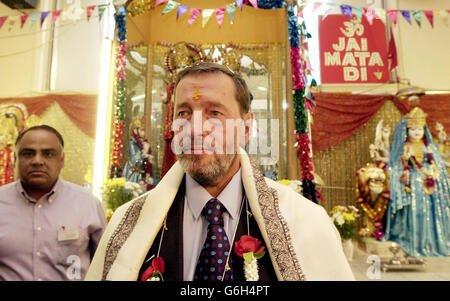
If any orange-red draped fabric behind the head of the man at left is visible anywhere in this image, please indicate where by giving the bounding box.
[0,94,98,138]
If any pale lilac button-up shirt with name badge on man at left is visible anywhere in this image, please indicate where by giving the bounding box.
[0,179,106,281]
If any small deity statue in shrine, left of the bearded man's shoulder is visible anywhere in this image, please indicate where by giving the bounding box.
[123,118,156,192]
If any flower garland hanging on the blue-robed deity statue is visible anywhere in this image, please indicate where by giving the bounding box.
[400,135,438,194]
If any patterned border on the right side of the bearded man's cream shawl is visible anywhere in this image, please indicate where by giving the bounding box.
[250,160,306,281]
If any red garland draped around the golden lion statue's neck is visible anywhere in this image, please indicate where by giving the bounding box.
[356,162,390,240]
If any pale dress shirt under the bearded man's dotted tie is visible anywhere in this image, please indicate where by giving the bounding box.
[183,169,243,281]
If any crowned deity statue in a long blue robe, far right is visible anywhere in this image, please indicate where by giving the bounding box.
[383,107,450,257]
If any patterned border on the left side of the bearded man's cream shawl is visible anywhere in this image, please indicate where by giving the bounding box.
[102,193,147,281]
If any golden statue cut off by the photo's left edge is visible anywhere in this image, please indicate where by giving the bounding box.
[0,113,18,186]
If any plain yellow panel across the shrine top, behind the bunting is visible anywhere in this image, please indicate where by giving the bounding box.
[127,0,287,45]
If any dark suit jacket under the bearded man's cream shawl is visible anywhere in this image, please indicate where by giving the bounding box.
[137,179,277,281]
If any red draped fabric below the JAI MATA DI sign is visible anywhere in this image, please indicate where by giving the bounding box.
[311,93,450,152]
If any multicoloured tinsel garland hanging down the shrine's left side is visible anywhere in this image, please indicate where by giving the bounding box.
[110,6,127,178]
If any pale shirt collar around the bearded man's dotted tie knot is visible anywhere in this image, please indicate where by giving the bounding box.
[186,169,243,219]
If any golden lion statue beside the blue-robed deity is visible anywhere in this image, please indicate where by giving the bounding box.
[356,162,389,240]
